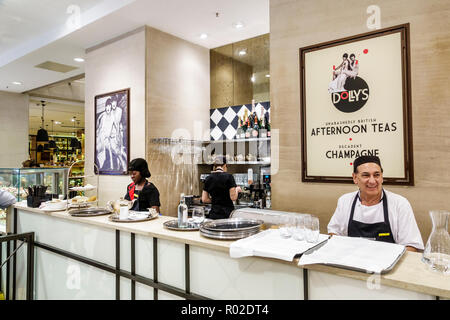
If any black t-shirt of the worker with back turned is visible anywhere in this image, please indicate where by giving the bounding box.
[203,171,236,208]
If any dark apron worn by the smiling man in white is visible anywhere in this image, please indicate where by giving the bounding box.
[347,190,395,243]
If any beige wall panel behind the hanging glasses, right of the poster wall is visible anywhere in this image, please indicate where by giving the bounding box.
[146,27,210,216]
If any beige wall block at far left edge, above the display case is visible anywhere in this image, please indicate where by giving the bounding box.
[0,91,28,168]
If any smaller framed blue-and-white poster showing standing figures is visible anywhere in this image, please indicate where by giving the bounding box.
[94,89,130,175]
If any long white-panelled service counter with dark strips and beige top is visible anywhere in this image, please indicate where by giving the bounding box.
[3,203,450,300]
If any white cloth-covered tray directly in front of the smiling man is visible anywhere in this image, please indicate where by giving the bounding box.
[298,236,405,273]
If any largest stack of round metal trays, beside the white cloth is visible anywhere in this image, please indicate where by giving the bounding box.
[200,218,264,240]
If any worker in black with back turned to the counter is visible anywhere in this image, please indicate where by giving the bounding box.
[202,157,240,219]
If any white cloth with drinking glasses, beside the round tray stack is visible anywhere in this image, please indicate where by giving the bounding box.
[230,229,329,261]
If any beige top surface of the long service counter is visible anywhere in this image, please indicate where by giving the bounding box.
[14,203,450,299]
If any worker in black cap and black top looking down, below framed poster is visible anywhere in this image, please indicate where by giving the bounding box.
[125,158,161,212]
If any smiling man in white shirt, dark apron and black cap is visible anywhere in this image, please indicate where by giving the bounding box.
[328,156,424,251]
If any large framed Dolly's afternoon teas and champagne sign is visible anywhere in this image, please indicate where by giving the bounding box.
[300,24,414,185]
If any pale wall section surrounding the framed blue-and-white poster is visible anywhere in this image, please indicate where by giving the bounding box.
[85,28,146,205]
